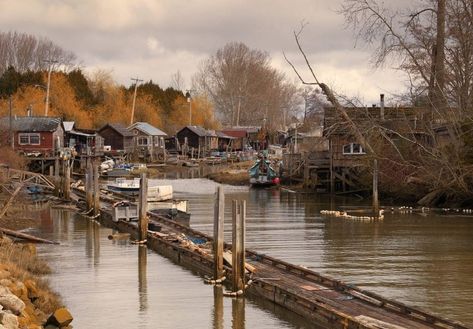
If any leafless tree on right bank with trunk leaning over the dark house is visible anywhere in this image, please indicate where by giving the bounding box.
[288,0,473,202]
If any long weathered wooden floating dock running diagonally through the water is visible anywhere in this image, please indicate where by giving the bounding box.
[75,190,467,329]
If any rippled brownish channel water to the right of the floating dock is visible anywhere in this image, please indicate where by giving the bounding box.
[156,179,473,325]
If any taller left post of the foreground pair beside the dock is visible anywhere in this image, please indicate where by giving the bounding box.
[214,186,225,280]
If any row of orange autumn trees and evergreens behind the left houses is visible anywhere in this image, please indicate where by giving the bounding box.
[0,69,217,134]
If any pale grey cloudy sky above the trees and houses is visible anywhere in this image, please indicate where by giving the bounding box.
[0,0,404,104]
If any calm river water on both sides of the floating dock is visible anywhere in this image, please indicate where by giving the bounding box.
[38,179,473,328]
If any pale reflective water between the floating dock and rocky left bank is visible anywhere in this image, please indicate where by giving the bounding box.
[34,210,311,329]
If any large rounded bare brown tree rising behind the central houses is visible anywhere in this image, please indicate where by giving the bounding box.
[193,43,297,128]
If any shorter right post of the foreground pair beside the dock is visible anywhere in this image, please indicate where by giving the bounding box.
[232,200,246,291]
